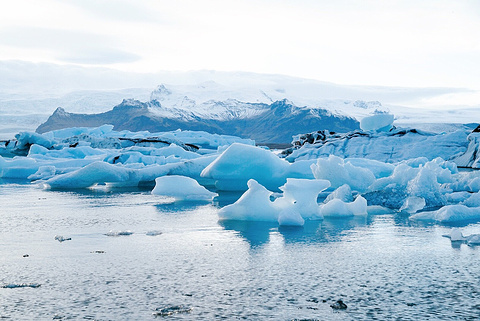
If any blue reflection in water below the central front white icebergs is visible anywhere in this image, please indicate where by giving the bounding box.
[218,217,372,248]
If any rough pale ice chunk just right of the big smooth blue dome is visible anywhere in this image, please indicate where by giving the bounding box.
[311,155,375,192]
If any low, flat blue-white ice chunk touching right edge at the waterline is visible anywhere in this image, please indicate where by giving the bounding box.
[410,204,480,223]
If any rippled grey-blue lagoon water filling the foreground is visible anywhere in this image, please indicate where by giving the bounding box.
[0,182,480,320]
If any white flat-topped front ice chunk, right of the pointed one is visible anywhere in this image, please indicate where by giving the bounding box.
[274,178,330,219]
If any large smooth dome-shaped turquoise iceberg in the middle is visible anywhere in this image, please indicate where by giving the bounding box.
[201,143,290,190]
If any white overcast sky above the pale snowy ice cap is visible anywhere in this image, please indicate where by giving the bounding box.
[0,0,480,89]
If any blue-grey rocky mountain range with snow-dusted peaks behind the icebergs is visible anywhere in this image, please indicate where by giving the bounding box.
[37,85,360,144]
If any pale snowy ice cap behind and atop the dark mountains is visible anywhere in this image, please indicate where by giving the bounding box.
[0,61,480,139]
